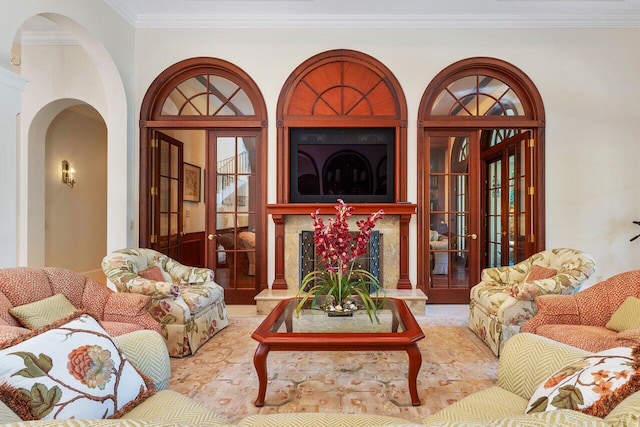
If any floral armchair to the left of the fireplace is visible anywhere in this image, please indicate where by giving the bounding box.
[102,248,229,357]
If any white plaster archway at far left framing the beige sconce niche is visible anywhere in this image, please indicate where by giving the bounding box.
[18,13,133,268]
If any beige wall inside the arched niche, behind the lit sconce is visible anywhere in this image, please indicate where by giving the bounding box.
[45,106,107,275]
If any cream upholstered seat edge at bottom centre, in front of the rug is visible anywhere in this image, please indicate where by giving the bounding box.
[238,413,416,427]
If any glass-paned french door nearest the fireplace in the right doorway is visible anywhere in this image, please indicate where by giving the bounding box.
[426,131,481,303]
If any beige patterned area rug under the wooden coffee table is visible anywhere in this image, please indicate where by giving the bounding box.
[170,316,498,423]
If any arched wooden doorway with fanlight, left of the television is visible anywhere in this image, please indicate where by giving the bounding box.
[140,57,267,304]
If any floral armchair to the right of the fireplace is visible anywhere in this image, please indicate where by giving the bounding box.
[469,248,595,356]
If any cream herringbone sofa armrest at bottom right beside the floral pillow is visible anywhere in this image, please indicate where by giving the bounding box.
[497,332,591,400]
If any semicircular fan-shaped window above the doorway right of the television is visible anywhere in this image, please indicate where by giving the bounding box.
[431,74,526,117]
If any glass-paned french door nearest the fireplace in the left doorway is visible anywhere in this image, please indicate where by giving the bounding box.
[206,130,262,304]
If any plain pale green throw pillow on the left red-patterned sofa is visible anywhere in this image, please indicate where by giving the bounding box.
[9,294,78,329]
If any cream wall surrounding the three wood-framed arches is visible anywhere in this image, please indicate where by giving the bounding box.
[135,29,640,283]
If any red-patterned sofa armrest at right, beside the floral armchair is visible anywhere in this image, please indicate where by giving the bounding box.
[522,295,581,333]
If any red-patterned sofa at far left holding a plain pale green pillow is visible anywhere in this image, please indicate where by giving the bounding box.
[0,267,160,341]
